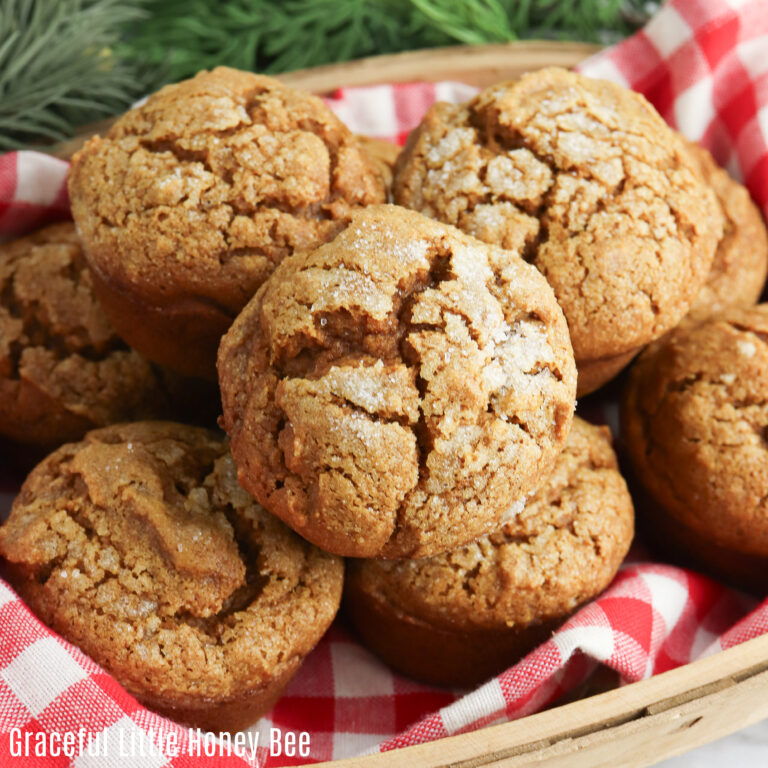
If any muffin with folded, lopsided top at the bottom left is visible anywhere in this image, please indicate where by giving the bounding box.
[0,422,343,731]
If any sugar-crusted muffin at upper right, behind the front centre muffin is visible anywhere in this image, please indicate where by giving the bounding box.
[394,68,721,395]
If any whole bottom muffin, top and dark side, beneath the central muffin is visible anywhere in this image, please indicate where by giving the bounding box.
[344,418,634,686]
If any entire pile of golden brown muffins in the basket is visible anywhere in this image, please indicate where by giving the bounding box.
[0,68,768,730]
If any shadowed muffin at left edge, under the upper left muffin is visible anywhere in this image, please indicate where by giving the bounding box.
[0,222,167,448]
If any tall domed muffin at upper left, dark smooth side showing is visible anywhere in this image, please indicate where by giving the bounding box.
[69,67,387,377]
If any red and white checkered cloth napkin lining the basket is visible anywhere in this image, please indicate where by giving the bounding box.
[0,0,768,768]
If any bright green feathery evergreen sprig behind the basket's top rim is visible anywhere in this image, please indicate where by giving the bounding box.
[125,0,658,86]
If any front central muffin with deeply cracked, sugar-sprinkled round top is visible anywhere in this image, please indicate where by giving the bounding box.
[219,206,576,557]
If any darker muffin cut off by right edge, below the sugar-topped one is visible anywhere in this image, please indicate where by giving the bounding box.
[622,304,768,592]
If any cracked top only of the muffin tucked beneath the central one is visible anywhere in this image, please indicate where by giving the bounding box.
[347,418,634,632]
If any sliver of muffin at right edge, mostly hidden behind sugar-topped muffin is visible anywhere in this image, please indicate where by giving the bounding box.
[687,142,768,320]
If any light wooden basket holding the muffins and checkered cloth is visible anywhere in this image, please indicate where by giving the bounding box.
[61,42,768,768]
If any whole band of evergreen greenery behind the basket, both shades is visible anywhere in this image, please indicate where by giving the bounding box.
[0,0,658,151]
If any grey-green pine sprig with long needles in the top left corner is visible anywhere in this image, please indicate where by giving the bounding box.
[0,0,146,150]
